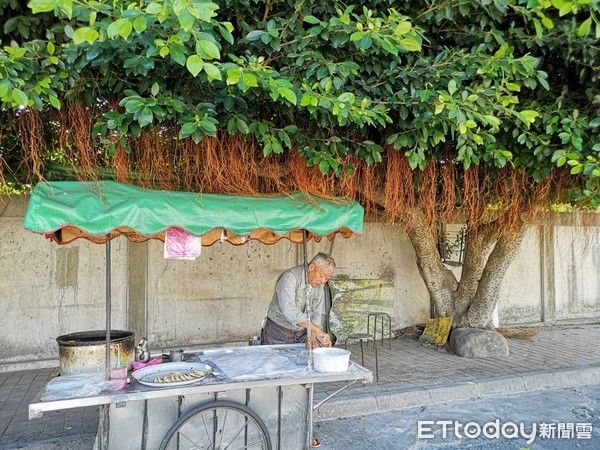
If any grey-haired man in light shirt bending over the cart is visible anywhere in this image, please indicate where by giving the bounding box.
[263,253,335,348]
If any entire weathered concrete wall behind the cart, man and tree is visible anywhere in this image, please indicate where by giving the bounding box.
[0,195,600,371]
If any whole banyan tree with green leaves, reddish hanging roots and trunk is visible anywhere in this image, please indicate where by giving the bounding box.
[0,0,600,356]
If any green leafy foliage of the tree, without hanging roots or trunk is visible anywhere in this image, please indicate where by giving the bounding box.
[0,0,600,207]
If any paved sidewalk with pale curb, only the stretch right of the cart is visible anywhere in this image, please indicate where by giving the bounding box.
[314,324,600,421]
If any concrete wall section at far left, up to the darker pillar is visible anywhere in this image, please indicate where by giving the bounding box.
[0,199,127,371]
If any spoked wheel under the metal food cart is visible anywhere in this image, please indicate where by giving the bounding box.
[160,400,272,450]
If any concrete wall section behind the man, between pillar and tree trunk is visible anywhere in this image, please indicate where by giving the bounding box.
[142,224,429,347]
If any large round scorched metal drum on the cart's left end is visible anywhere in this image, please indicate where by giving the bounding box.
[56,330,135,375]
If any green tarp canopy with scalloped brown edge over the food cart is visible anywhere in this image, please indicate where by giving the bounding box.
[24,181,364,245]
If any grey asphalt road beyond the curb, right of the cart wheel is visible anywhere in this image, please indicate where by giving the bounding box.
[315,385,600,450]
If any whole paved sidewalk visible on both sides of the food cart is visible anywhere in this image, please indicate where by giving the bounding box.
[0,324,600,450]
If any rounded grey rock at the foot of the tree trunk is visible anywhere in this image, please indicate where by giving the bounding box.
[450,328,508,358]
